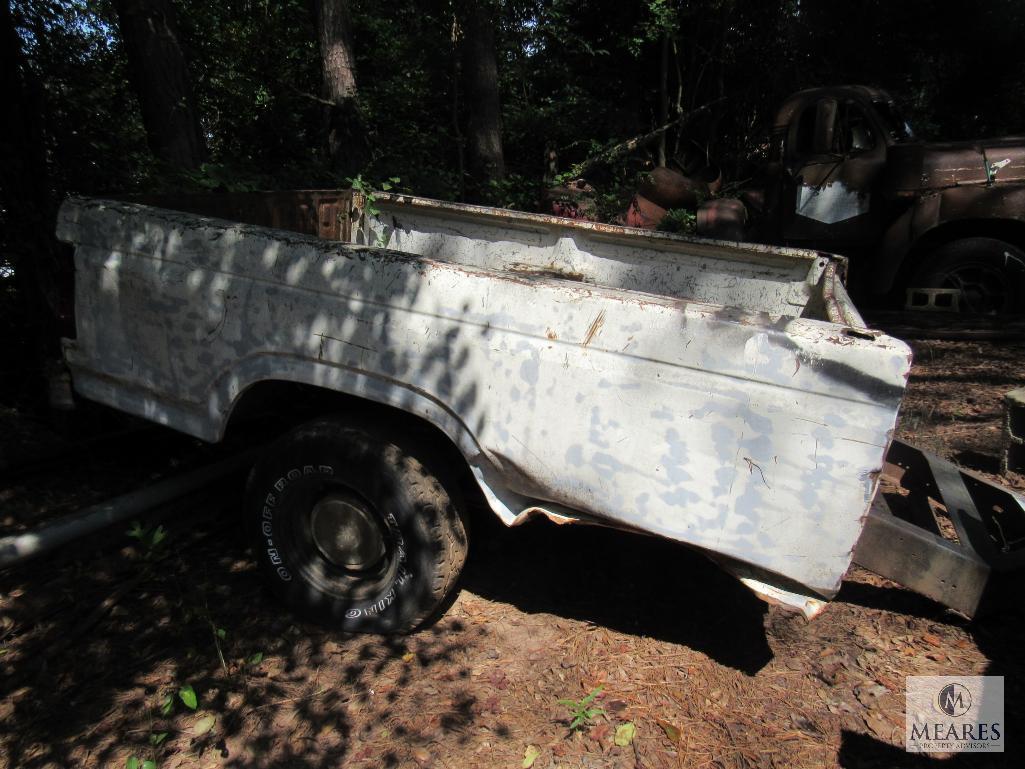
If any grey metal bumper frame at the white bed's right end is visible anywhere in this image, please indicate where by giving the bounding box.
[854,440,1025,617]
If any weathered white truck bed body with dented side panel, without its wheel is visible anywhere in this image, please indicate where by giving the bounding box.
[57,196,910,615]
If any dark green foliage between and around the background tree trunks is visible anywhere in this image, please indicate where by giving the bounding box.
[8,0,1025,219]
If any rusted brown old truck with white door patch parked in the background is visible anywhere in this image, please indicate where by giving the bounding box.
[752,86,1025,314]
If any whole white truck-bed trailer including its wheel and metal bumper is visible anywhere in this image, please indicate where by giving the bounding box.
[57,191,1020,632]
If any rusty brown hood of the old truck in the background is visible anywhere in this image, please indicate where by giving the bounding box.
[887,136,1025,192]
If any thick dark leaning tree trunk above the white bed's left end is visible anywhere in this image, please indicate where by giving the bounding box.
[114,0,206,168]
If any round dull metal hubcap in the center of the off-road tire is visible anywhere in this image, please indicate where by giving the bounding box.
[310,492,384,571]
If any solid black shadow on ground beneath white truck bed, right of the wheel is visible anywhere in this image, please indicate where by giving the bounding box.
[462,513,772,675]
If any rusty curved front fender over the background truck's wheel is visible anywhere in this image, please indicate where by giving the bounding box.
[870,185,1025,294]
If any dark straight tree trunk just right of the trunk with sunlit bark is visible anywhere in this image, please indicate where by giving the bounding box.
[462,0,505,202]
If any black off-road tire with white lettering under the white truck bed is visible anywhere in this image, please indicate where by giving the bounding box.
[246,419,467,633]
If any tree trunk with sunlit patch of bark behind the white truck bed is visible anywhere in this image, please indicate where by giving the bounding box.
[314,0,366,176]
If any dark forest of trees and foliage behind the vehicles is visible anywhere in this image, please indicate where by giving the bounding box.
[0,0,1025,410]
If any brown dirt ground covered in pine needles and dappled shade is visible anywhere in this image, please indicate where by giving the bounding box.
[0,341,1025,769]
